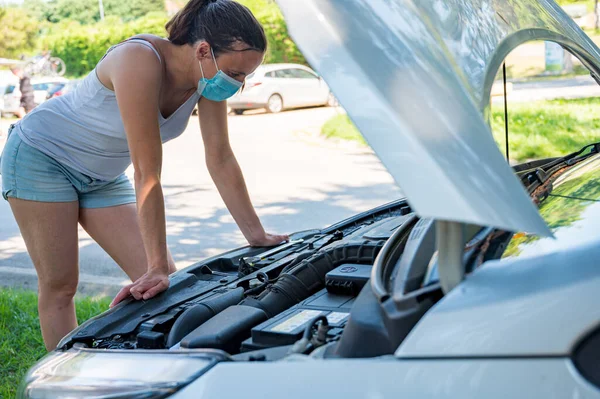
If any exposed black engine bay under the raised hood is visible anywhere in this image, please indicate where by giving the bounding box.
[59,148,591,361]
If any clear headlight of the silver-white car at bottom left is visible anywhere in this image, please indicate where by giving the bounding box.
[18,349,215,399]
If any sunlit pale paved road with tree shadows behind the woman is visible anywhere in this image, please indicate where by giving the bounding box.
[0,108,401,295]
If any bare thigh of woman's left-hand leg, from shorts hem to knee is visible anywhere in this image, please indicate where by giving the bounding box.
[8,198,79,295]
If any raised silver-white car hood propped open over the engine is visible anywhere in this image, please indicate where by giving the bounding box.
[277,0,600,235]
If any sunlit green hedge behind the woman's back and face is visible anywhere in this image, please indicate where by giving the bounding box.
[40,0,306,77]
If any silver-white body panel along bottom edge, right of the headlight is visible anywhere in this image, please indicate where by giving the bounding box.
[171,357,600,399]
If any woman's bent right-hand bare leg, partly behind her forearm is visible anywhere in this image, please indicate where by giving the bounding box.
[79,204,176,281]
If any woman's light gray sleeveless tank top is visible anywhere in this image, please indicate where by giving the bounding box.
[15,39,200,181]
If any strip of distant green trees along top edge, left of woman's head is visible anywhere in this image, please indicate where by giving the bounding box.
[24,0,165,24]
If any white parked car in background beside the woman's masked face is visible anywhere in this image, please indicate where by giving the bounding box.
[227,64,337,115]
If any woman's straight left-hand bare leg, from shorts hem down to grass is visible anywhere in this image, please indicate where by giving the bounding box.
[8,198,79,351]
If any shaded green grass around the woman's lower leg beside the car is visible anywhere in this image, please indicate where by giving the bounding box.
[0,288,110,399]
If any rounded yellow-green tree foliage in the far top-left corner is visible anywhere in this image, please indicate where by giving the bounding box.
[0,7,39,58]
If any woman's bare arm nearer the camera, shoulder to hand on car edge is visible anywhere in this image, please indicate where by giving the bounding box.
[99,44,169,305]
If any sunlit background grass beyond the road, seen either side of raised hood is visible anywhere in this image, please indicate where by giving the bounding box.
[322,97,600,161]
